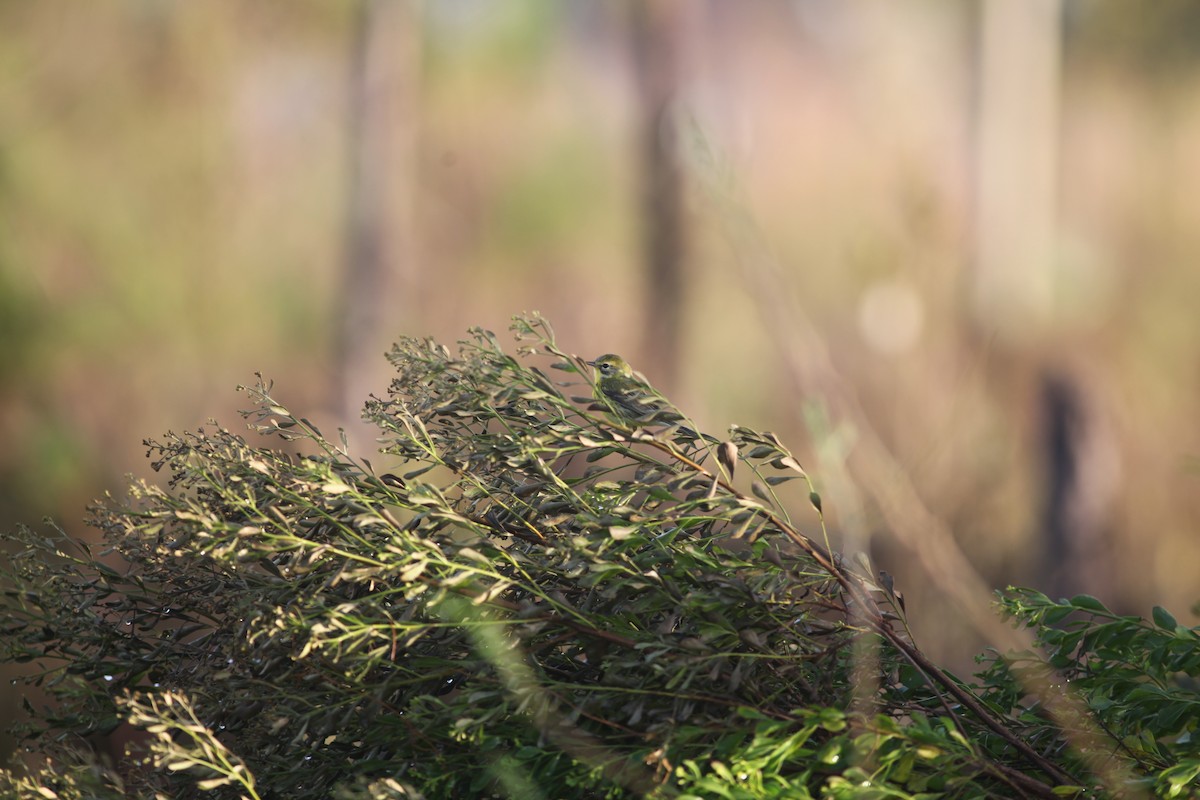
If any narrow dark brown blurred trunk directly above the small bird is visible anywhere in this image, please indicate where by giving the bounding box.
[632,0,686,387]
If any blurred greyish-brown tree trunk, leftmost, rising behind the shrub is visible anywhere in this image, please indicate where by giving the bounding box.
[331,0,420,434]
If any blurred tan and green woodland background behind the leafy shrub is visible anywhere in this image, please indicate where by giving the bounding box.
[0,0,1200,758]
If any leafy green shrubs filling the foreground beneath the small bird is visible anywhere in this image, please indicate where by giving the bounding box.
[0,318,1200,798]
